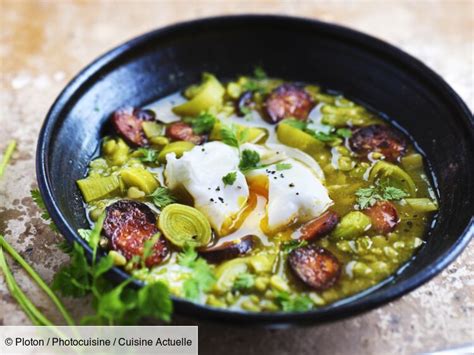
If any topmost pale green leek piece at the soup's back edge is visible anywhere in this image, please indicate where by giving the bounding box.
[173,73,225,116]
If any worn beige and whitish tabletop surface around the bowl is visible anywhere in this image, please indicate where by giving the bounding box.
[0,0,474,354]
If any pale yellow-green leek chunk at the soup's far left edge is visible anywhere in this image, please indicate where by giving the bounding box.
[77,175,120,203]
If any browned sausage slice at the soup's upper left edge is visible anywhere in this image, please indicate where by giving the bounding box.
[112,107,155,147]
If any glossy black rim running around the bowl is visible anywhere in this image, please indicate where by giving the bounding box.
[36,14,474,326]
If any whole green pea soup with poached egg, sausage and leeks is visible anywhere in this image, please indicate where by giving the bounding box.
[77,69,437,312]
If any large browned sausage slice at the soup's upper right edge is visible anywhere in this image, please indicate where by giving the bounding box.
[349,124,407,162]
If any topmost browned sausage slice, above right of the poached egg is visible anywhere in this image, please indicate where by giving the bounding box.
[264,84,315,123]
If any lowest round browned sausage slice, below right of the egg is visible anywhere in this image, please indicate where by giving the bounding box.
[288,246,341,291]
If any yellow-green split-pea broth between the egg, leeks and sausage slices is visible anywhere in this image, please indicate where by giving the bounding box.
[77,73,436,312]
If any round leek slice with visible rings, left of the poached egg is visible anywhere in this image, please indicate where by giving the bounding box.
[158,203,211,248]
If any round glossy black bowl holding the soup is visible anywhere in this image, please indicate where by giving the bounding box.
[36,15,474,325]
